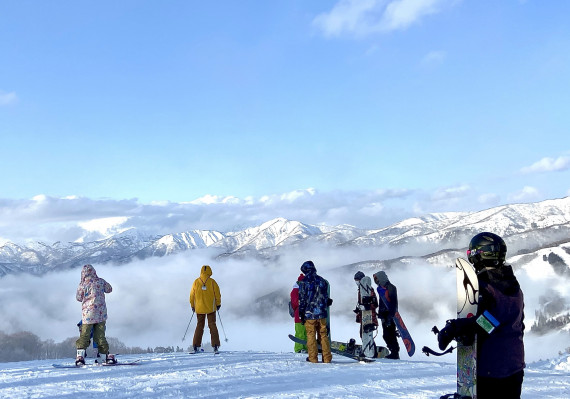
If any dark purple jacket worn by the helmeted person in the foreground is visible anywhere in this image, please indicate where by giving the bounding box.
[477,266,525,378]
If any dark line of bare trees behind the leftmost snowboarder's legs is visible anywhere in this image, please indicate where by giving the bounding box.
[0,331,184,363]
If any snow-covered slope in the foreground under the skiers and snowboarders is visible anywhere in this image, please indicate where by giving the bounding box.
[0,351,570,399]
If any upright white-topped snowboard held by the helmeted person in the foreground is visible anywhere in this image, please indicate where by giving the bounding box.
[455,258,479,399]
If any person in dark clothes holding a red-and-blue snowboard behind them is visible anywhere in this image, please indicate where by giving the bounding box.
[374,271,400,359]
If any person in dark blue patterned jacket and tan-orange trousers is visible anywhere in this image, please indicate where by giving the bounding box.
[298,260,332,363]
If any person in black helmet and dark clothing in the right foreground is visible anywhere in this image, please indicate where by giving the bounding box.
[438,232,525,399]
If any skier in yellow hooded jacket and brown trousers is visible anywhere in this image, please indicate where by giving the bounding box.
[190,265,222,352]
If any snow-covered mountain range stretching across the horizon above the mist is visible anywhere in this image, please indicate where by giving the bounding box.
[0,197,570,277]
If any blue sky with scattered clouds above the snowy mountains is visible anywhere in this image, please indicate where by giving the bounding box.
[0,0,570,242]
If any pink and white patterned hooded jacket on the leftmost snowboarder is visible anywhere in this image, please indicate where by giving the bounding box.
[75,265,113,324]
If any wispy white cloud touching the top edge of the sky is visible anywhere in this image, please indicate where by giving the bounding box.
[313,0,455,37]
